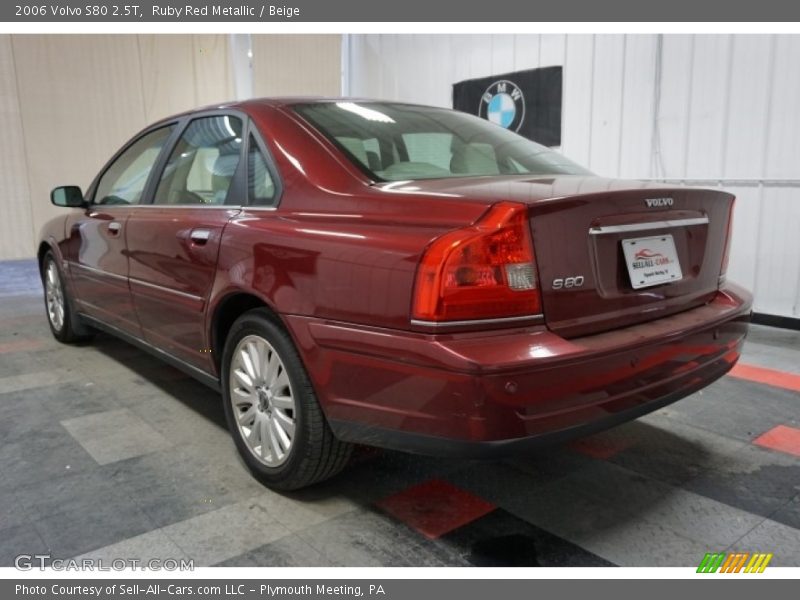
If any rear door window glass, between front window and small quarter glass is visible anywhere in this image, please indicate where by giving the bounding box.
[153,115,242,205]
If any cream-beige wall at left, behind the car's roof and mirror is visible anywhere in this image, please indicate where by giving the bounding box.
[0,34,342,260]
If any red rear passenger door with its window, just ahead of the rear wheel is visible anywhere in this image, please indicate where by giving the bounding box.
[127,112,245,371]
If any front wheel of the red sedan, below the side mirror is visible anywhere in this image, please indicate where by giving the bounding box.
[42,250,94,344]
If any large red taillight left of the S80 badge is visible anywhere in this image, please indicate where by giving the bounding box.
[412,202,542,321]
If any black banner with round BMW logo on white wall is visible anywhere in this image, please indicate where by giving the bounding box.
[453,67,562,146]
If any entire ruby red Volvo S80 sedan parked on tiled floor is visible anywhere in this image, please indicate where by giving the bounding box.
[38,98,751,490]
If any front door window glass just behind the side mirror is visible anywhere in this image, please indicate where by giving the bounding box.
[94,125,174,205]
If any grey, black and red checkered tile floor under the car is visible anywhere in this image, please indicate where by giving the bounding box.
[0,261,800,566]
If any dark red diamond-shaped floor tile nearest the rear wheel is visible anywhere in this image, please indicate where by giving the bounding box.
[377,479,495,539]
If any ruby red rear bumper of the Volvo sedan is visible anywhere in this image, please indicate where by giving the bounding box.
[286,284,752,457]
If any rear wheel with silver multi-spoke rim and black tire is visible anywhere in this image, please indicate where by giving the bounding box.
[221,309,352,491]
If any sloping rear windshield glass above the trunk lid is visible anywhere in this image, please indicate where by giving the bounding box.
[294,102,589,181]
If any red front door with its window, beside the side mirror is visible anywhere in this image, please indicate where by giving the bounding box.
[66,124,176,336]
